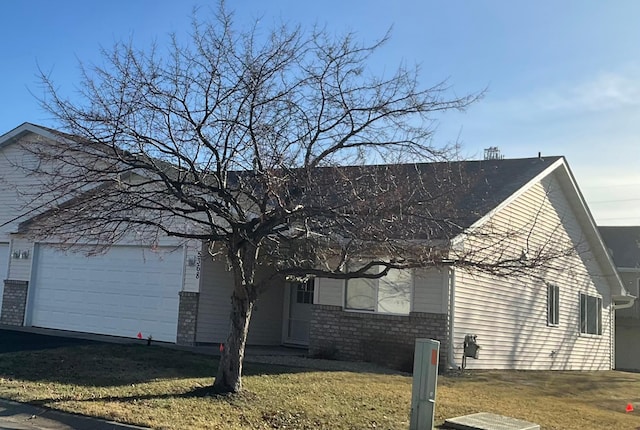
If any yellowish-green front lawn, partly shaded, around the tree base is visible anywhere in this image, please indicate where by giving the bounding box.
[0,344,640,429]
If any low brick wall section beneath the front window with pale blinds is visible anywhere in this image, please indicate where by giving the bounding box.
[309,305,448,372]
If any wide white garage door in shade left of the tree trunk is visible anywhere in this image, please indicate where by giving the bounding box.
[29,245,183,342]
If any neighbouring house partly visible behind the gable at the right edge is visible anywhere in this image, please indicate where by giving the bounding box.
[598,226,640,370]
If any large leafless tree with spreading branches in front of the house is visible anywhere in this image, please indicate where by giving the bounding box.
[3,5,576,392]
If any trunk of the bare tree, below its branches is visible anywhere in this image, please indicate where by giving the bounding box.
[213,289,254,393]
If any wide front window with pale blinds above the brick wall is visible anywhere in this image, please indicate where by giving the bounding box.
[345,268,413,315]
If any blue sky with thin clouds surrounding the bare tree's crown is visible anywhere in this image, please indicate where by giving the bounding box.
[0,0,640,225]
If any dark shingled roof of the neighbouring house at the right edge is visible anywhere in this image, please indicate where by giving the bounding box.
[598,226,640,269]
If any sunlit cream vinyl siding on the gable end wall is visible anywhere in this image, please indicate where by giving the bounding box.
[454,174,612,370]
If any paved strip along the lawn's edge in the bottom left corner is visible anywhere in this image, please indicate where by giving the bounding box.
[0,399,145,430]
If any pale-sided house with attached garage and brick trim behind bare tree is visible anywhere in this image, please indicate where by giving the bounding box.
[0,123,632,370]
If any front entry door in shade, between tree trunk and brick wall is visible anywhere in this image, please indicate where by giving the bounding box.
[284,279,314,345]
